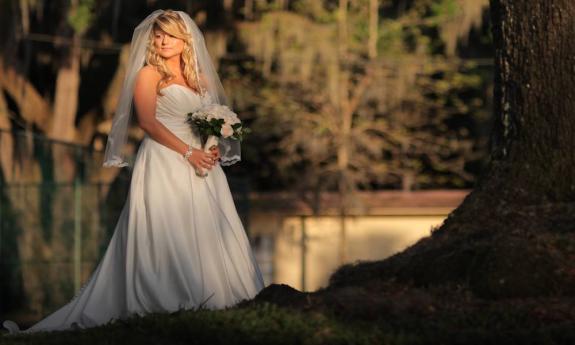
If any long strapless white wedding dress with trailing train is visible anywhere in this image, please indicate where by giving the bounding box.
[4,84,264,333]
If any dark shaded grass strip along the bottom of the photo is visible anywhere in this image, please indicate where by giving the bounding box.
[0,290,575,345]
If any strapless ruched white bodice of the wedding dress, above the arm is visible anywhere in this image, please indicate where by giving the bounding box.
[156,84,207,147]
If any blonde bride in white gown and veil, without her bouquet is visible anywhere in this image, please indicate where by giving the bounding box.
[3,10,264,333]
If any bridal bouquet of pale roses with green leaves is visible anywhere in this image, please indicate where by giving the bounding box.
[187,103,250,177]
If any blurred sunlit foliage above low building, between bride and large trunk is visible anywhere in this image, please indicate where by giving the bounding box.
[228,0,491,190]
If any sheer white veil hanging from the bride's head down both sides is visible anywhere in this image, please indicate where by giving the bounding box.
[104,10,241,167]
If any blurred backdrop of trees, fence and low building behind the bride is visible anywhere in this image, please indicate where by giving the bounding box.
[0,0,493,323]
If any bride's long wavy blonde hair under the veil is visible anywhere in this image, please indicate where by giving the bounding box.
[146,10,201,95]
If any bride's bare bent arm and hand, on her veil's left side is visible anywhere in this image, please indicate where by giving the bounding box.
[134,66,215,169]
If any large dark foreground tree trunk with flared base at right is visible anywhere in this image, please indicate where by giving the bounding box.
[331,0,575,298]
